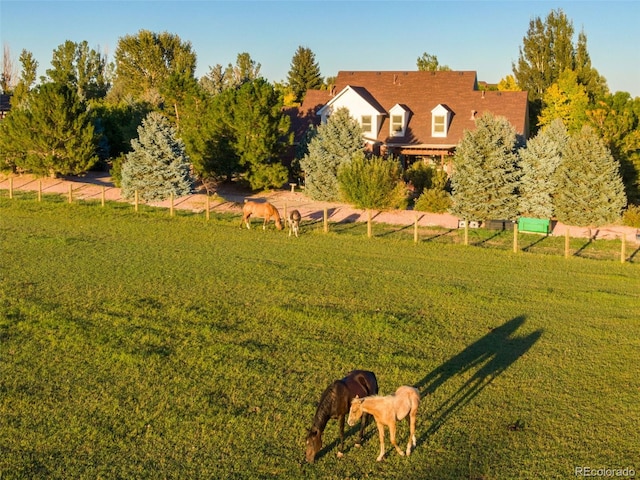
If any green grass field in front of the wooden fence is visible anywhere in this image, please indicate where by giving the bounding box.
[0,193,640,480]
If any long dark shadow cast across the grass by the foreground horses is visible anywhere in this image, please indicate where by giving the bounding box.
[415,315,543,442]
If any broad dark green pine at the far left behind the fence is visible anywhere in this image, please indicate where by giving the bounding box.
[0,83,98,176]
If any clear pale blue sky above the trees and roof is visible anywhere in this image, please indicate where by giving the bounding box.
[0,0,640,97]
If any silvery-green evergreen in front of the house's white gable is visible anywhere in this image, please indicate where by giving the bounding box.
[300,108,364,201]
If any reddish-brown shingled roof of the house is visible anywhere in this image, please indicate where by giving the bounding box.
[301,71,528,147]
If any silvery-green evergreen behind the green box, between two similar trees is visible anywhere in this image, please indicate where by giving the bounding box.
[518,120,569,218]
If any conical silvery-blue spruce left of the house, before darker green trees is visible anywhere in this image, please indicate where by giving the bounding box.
[122,112,193,201]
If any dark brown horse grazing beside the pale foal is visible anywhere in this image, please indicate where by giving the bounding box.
[305,370,378,463]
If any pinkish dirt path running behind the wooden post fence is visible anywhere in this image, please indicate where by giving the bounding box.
[0,172,640,244]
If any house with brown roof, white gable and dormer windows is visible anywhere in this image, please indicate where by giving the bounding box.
[298,71,529,168]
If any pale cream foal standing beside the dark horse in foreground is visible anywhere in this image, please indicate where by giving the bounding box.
[347,385,420,461]
